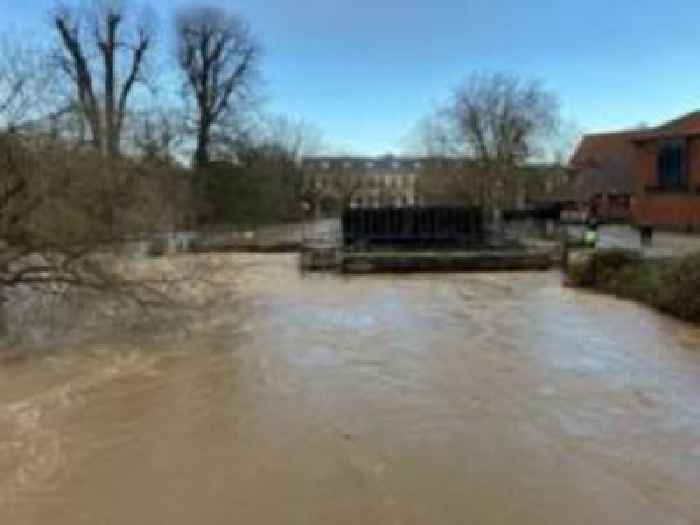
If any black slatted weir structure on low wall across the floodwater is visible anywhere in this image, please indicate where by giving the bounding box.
[300,206,553,274]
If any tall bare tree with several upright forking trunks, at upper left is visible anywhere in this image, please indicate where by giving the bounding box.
[53,0,152,157]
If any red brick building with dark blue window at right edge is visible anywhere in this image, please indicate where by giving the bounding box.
[632,111,700,231]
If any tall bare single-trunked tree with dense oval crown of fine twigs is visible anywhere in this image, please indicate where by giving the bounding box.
[176,7,259,167]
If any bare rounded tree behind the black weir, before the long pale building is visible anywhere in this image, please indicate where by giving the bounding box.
[420,73,559,208]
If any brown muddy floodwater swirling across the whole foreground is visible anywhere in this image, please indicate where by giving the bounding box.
[0,255,700,525]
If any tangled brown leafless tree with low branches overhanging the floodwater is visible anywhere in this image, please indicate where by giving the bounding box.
[0,126,208,335]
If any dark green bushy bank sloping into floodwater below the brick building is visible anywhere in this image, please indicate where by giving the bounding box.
[568,249,700,323]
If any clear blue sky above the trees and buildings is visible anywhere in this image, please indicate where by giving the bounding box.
[0,0,700,154]
